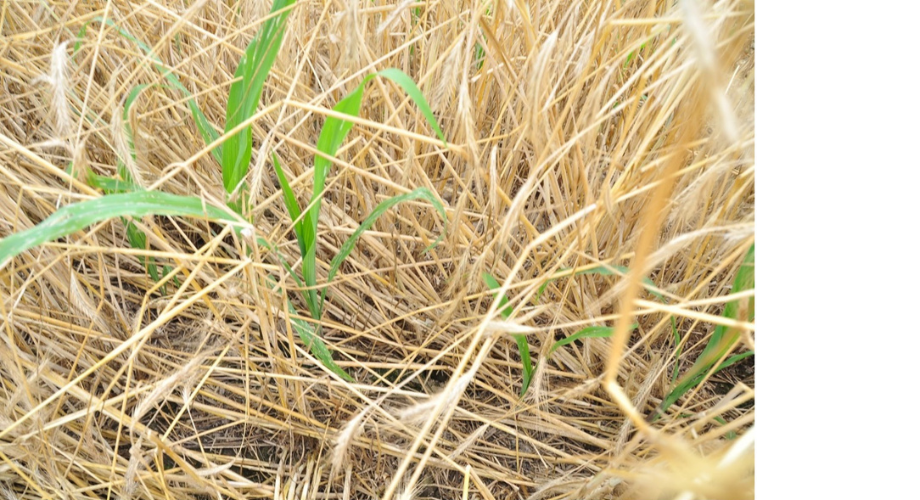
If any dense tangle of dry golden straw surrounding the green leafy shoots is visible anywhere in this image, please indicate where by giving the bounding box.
[0,0,755,500]
